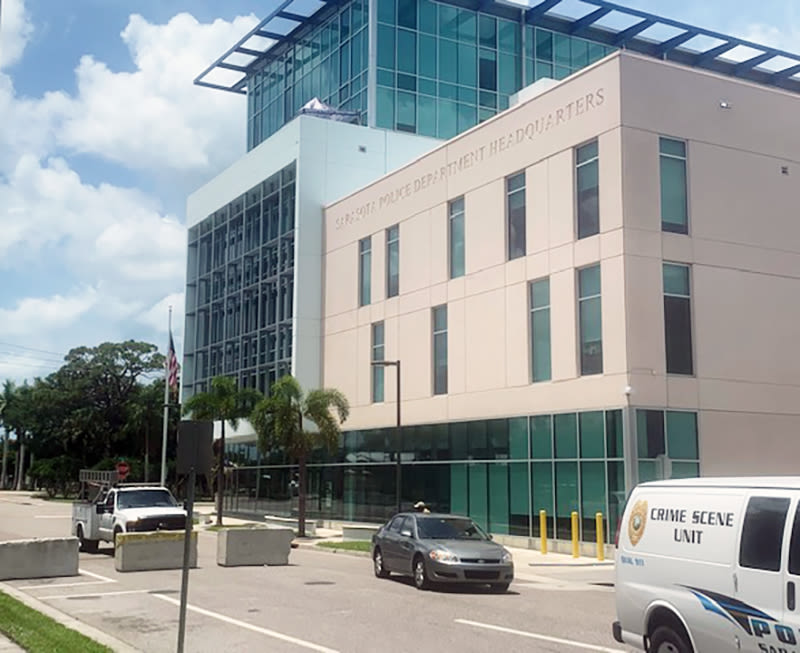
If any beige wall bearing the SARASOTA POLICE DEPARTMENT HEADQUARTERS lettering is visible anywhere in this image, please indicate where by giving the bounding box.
[324,58,626,428]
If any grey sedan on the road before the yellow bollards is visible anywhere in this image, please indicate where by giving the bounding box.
[372,513,514,592]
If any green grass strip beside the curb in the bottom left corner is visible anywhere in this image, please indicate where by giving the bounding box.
[0,592,111,653]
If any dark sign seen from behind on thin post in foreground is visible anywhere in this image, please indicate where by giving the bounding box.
[177,420,214,653]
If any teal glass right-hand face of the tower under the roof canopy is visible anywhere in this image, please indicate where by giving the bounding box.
[376,0,613,138]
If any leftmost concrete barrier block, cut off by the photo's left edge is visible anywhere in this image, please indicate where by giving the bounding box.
[0,537,78,580]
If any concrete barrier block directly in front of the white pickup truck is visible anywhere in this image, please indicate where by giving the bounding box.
[114,531,197,571]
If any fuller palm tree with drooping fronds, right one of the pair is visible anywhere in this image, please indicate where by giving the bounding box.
[250,375,350,537]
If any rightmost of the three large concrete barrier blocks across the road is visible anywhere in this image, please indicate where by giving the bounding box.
[217,527,294,567]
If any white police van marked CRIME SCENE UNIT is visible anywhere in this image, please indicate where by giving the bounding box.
[613,477,800,653]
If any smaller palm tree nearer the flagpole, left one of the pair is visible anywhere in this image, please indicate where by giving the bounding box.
[183,376,264,526]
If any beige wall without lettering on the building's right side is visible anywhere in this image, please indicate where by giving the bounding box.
[620,56,800,475]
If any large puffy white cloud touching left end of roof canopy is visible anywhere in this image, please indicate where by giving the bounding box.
[59,13,258,172]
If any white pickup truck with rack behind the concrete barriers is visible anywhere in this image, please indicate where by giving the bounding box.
[72,485,186,552]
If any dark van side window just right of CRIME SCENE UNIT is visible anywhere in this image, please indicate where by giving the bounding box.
[739,497,789,571]
